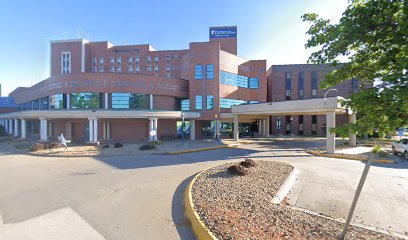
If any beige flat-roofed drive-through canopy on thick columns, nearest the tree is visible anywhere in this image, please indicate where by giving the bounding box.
[229,97,356,153]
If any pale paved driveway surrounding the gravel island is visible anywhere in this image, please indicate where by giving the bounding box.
[0,139,408,240]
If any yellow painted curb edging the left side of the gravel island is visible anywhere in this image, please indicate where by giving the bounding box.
[184,170,217,240]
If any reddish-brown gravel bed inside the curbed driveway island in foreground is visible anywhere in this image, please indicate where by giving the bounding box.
[192,161,398,240]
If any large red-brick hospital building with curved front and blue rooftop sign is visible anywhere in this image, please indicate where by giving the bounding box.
[0,26,358,142]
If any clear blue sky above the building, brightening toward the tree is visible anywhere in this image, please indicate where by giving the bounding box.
[0,0,348,96]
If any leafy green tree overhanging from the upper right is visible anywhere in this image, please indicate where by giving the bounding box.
[302,0,408,136]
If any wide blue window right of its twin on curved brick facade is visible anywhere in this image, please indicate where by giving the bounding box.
[112,93,147,109]
